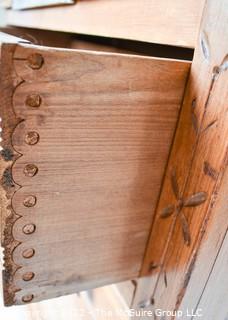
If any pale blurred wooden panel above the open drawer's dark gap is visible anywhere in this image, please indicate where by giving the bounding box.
[7,0,204,48]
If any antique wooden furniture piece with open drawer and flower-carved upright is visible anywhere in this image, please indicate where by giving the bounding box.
[0,0,228,319]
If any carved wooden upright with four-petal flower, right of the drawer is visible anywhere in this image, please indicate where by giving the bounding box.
[134,0,228,310]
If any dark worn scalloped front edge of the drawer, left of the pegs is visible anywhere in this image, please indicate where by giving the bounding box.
[0,44,23,306]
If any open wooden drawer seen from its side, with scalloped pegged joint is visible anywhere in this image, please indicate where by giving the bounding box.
[0,31,190,305]
